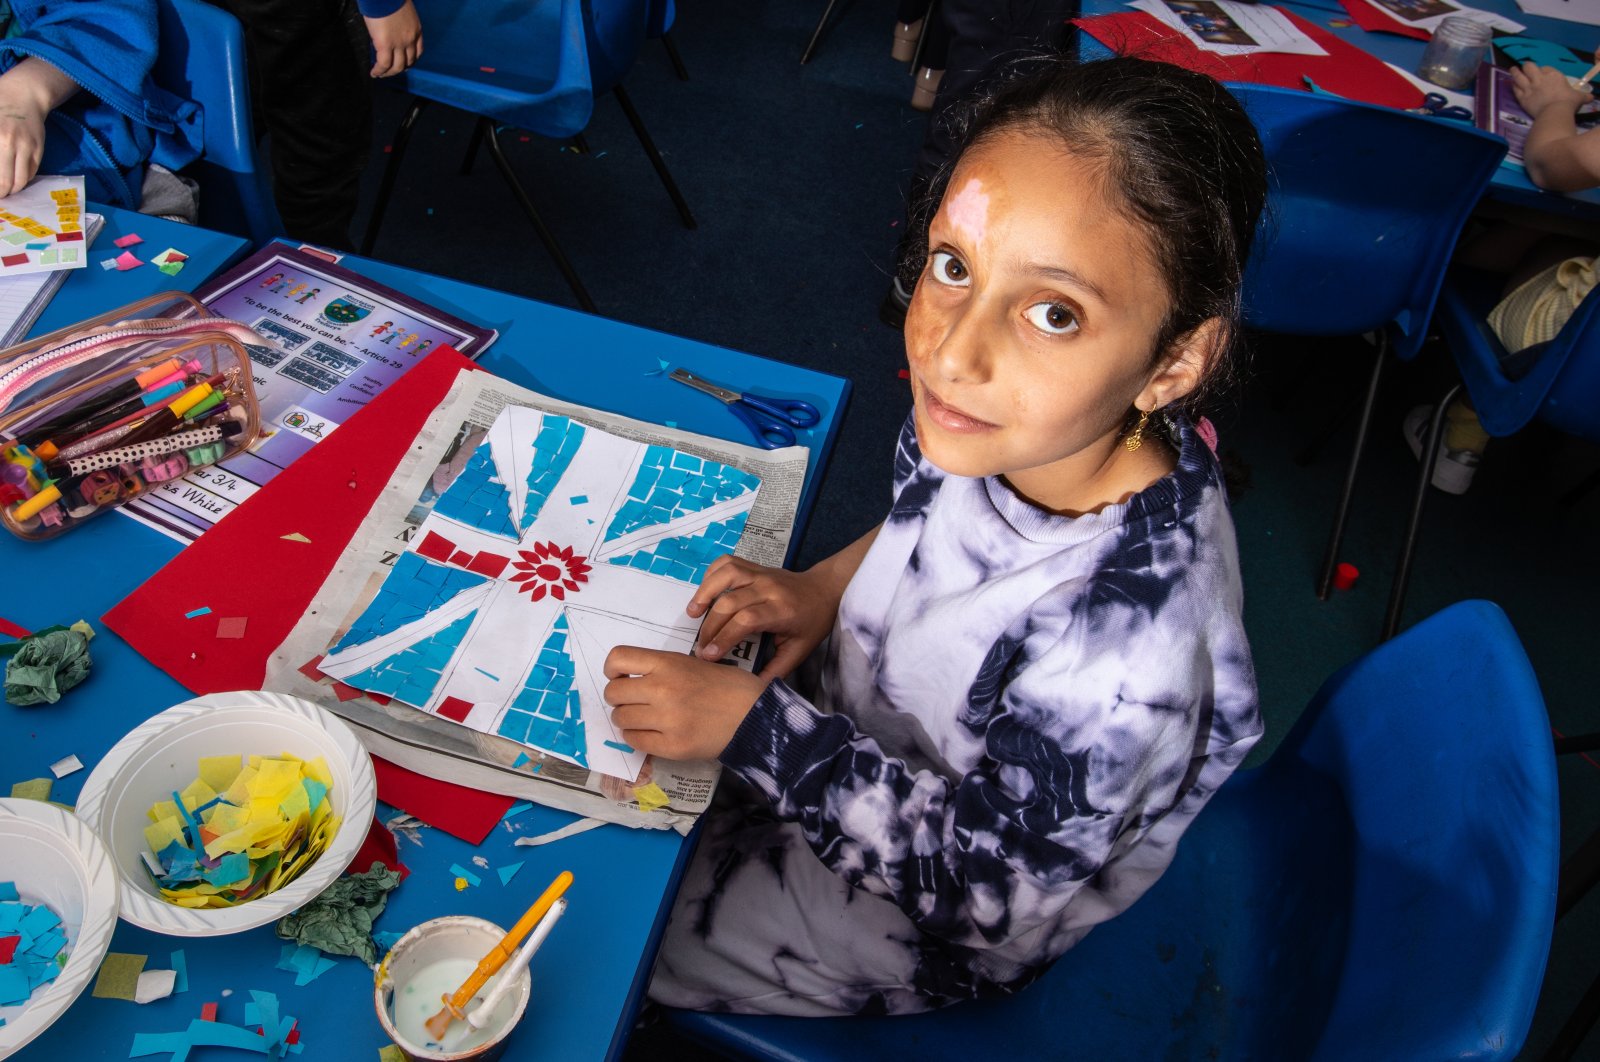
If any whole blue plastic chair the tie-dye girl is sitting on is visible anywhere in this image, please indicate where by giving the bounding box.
[667,601,1558,1062]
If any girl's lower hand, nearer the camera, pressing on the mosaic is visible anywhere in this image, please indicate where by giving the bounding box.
[605,645,766,760]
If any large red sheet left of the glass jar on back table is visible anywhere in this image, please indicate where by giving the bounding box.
[1074,8,1422,109]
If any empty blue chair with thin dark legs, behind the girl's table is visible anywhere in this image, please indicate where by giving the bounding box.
[362,0,694,313]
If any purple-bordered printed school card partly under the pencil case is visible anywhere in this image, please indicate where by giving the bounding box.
[120,243,498,542]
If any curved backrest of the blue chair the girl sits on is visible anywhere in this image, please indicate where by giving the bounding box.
[1264,601,1560,1059]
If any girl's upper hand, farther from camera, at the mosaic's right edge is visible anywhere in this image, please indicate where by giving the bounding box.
[685,555,838,680]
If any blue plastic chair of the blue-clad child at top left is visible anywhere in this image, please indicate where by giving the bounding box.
[154,0,283,243]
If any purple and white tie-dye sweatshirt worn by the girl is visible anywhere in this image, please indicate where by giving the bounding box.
[722,412,1261,982]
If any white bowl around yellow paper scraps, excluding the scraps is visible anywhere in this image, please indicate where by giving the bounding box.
[77,691,378,937]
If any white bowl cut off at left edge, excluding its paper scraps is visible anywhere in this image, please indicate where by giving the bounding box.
[0,800,117,1059]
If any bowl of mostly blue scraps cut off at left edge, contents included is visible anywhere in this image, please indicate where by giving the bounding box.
[0,800,117,1059]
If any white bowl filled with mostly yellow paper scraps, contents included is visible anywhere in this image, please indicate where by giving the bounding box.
[77,691,378,937]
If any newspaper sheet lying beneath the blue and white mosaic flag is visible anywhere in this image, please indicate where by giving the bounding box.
[266,371,810,833]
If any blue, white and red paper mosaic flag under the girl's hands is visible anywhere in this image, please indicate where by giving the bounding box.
[318,406,760,781]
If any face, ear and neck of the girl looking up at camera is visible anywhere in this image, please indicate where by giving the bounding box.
[906,131,1208,512]
